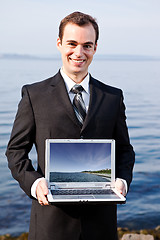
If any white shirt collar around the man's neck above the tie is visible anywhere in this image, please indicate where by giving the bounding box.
[60,68,90,94]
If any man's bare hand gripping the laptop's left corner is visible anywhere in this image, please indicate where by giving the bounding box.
[36,179,49,206]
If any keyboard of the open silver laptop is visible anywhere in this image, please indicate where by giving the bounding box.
[51,189,114,195]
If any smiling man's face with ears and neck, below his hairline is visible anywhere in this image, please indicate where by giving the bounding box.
[57,23,97,83]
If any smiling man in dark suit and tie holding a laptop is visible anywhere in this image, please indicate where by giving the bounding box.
[6,12,134,240]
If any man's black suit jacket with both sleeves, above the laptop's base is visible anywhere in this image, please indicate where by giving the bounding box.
[6,72,134,239]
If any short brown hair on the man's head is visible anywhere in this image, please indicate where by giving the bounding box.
[59,12,99,43]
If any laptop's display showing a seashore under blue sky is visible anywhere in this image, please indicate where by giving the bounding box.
[50,142,111,182]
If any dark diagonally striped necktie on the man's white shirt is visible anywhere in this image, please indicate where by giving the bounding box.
[71,85,86,126]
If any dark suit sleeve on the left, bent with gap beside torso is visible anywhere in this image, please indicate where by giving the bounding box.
[6,86,42,197]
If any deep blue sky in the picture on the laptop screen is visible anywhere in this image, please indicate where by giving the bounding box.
[50,143,111,172]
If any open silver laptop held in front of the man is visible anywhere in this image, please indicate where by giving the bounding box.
[45,139,126,204]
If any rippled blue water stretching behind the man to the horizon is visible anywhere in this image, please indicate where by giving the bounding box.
[0,57,160,235]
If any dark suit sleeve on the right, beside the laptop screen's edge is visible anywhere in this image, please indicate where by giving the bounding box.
[115,91,135,189]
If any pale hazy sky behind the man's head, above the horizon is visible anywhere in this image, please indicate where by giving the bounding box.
[0,0,160,56]
